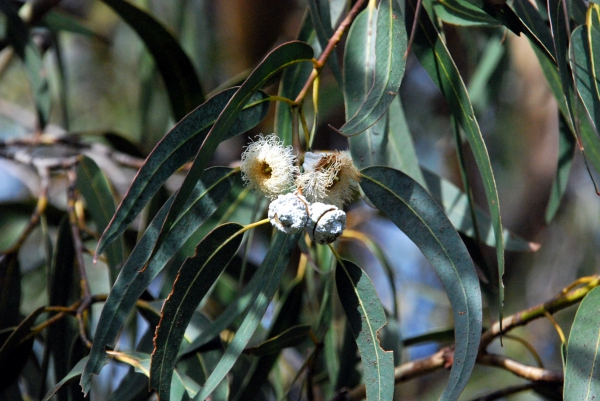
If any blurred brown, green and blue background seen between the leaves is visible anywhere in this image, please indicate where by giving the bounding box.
[0,0,600,400]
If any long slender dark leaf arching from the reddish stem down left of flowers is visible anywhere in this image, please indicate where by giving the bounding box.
[156,41,313,260]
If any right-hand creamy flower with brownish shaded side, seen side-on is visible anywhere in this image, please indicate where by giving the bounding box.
[296,152,360,208]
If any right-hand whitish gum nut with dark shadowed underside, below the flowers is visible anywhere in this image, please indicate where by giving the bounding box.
[307,202,346,245]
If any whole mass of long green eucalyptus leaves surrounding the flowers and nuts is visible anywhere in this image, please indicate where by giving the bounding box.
[0,0,600,400]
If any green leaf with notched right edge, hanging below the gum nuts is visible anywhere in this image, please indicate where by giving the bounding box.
[335,260,394,400]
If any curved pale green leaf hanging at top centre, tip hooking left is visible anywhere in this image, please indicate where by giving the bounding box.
[340,0,407,136]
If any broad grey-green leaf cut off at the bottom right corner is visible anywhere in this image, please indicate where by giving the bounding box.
[564,288,600,401]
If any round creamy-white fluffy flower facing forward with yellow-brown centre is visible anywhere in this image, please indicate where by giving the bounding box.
[241,134,299,199]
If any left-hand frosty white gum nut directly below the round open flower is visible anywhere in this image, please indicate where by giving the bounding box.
[269,193,308,234]
